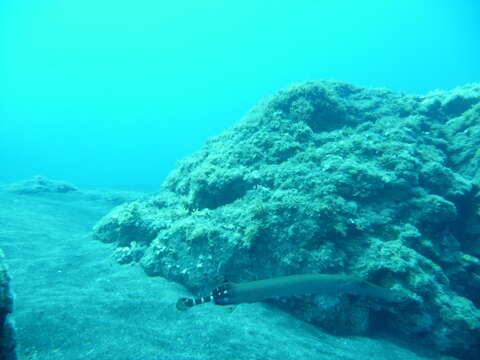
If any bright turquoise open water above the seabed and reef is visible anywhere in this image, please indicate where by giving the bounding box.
[0,0,480,189]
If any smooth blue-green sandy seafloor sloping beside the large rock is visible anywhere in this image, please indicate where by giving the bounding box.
[0,184,438,360]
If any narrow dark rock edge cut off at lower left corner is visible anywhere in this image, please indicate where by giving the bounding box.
[0,250,17,360]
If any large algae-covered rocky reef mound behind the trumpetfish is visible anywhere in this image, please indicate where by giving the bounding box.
[94,81,480,359]
